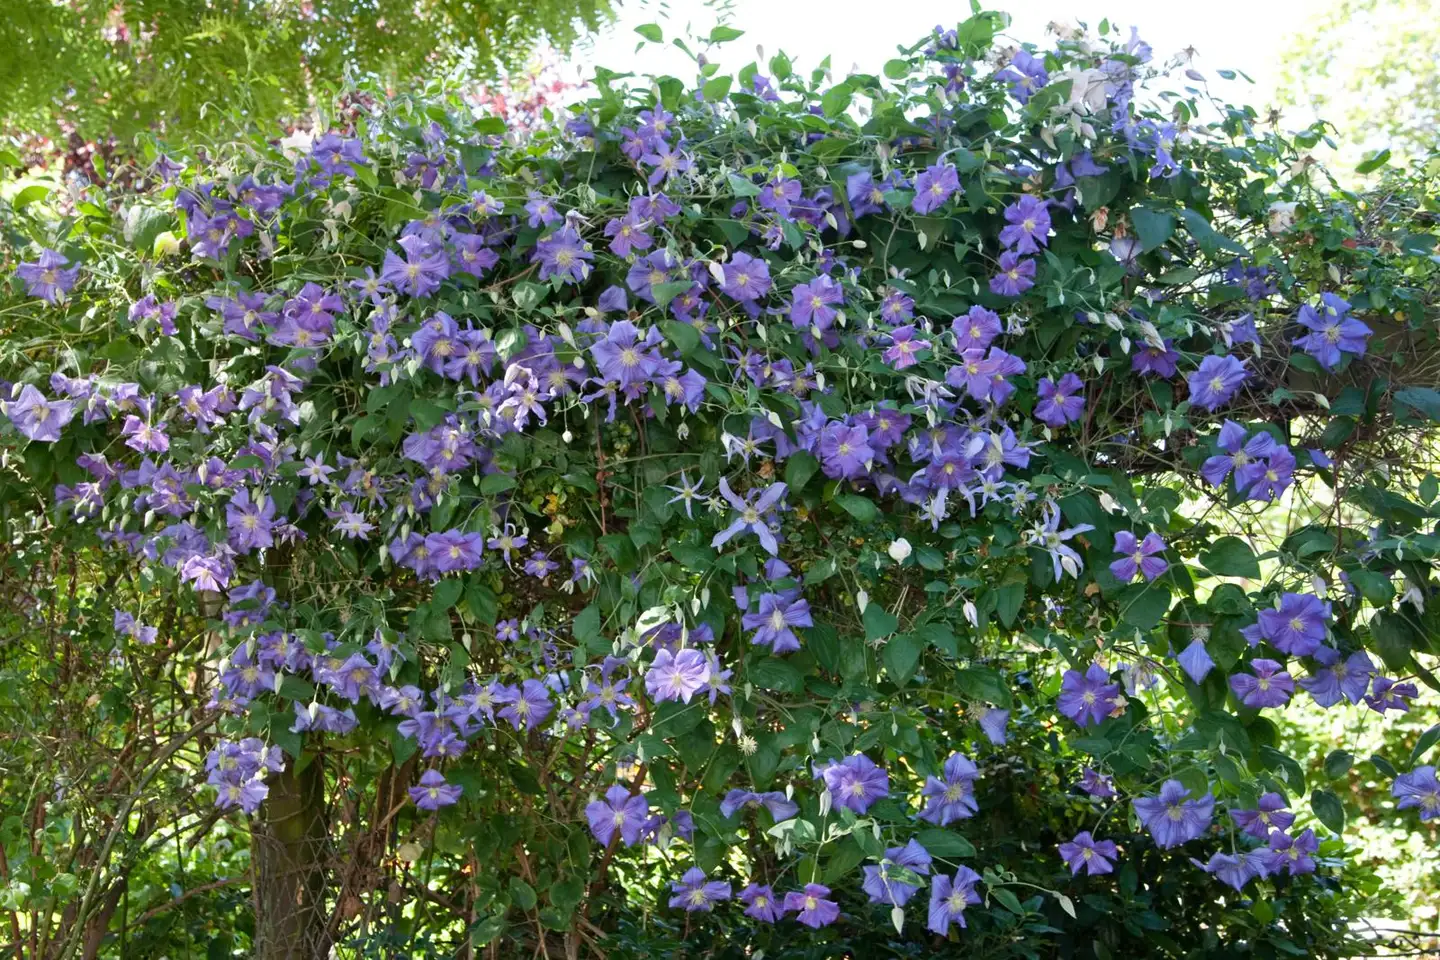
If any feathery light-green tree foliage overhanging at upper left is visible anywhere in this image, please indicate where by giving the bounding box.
[0,0,611,137]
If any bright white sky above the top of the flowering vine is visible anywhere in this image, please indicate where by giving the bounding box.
[575,0,1323,112]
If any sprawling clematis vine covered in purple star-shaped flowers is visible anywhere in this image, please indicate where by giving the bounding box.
[0,12,1440,959]
